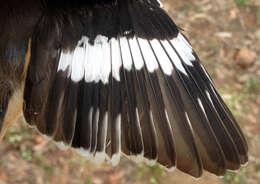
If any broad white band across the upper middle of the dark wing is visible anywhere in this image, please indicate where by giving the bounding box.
[58,33,196,84]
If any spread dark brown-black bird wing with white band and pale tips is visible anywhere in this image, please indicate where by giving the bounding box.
[24,0,248,177]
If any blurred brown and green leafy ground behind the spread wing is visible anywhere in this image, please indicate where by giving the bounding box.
[0,0,260,184]
